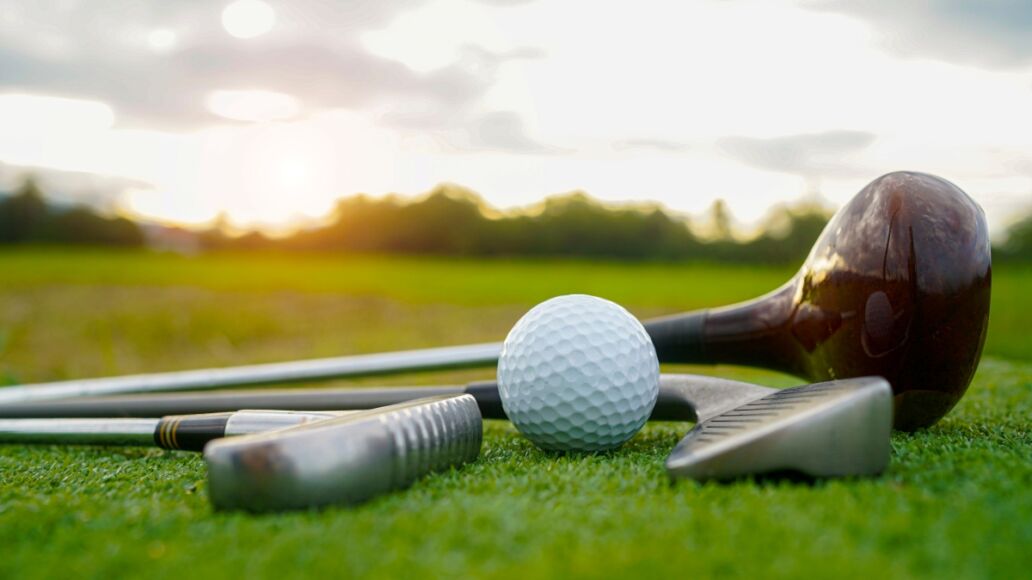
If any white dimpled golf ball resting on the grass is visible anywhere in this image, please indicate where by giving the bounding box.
[498,294,659,451]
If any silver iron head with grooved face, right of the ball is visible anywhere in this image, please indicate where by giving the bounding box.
[667,377,893,480]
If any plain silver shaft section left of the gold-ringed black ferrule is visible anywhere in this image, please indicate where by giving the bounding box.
[0,419,158,445]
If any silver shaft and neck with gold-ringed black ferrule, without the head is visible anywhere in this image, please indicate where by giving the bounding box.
[0,410,355,451]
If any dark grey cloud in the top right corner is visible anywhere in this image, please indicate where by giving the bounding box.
[804,0,1032,68]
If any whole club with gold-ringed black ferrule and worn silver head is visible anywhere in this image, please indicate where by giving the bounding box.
[0,394,483,512]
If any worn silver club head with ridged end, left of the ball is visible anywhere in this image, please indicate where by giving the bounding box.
[204,394,483,512]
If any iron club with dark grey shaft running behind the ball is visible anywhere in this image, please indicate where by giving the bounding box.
[4,375,893,479]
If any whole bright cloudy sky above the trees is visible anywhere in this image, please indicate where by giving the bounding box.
[0,0,1032,235]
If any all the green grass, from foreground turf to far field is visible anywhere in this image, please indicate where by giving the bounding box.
[0,245,1032,578]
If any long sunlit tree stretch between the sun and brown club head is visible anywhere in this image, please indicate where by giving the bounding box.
[204,185,829,262]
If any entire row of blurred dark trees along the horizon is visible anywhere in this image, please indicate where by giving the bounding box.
[0,180,1032,263]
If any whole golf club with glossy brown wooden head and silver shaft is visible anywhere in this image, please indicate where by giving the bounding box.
[0,172,992,429]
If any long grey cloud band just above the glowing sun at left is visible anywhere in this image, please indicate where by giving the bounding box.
[0,43,489,128]
